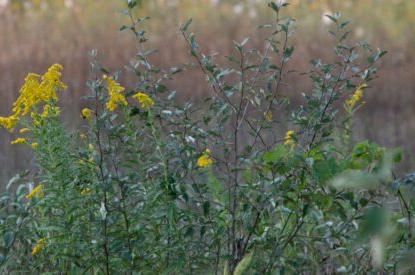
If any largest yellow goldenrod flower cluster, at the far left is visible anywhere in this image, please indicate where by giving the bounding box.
[0,64,67,131]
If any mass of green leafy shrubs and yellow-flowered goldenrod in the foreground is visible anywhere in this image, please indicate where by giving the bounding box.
[0,1,413,274]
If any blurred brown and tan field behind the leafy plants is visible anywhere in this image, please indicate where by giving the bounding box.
[0,0,415,185]
